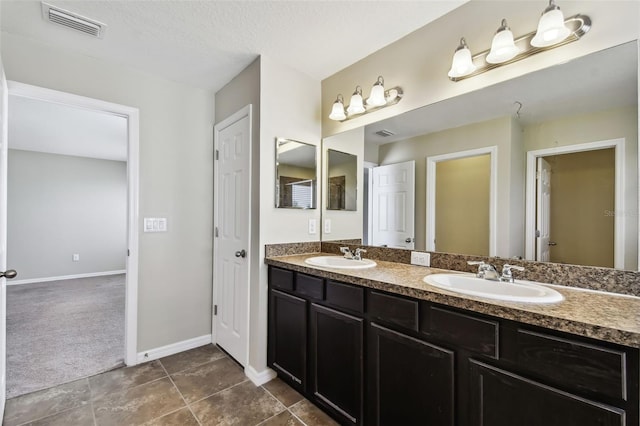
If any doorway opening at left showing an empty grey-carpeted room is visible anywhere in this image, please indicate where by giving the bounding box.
[6,82,139,398]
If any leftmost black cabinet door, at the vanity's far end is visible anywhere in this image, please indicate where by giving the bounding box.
[268,289,307,391]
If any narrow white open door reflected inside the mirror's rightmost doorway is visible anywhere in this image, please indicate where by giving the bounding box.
[536,157,551,262]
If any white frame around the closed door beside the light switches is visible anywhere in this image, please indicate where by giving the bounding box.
[211,104,253,371]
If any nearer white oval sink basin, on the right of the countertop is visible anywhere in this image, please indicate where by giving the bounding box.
[423,274,564,303]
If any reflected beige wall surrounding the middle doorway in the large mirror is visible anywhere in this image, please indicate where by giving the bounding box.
[378,117,524,257]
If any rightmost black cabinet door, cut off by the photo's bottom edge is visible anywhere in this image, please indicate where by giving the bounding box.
[470,360,625,426]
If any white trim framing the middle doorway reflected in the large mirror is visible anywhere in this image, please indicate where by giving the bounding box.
[426,145,498,256]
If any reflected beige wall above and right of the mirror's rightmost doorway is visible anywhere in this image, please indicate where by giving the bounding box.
[523,106,638,270]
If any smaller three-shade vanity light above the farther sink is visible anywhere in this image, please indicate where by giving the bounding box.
[329,76,403,121]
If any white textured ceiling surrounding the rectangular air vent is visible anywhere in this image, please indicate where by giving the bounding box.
[0,0,466,90]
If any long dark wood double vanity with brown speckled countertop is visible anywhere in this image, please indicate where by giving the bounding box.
[266,255,640,426]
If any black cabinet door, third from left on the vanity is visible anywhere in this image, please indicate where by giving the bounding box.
[367,324,454,426]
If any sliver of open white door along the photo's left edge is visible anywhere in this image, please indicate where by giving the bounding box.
[0,56,9,418]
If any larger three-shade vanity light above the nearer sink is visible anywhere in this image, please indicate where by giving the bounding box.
[448,0,591,81]
